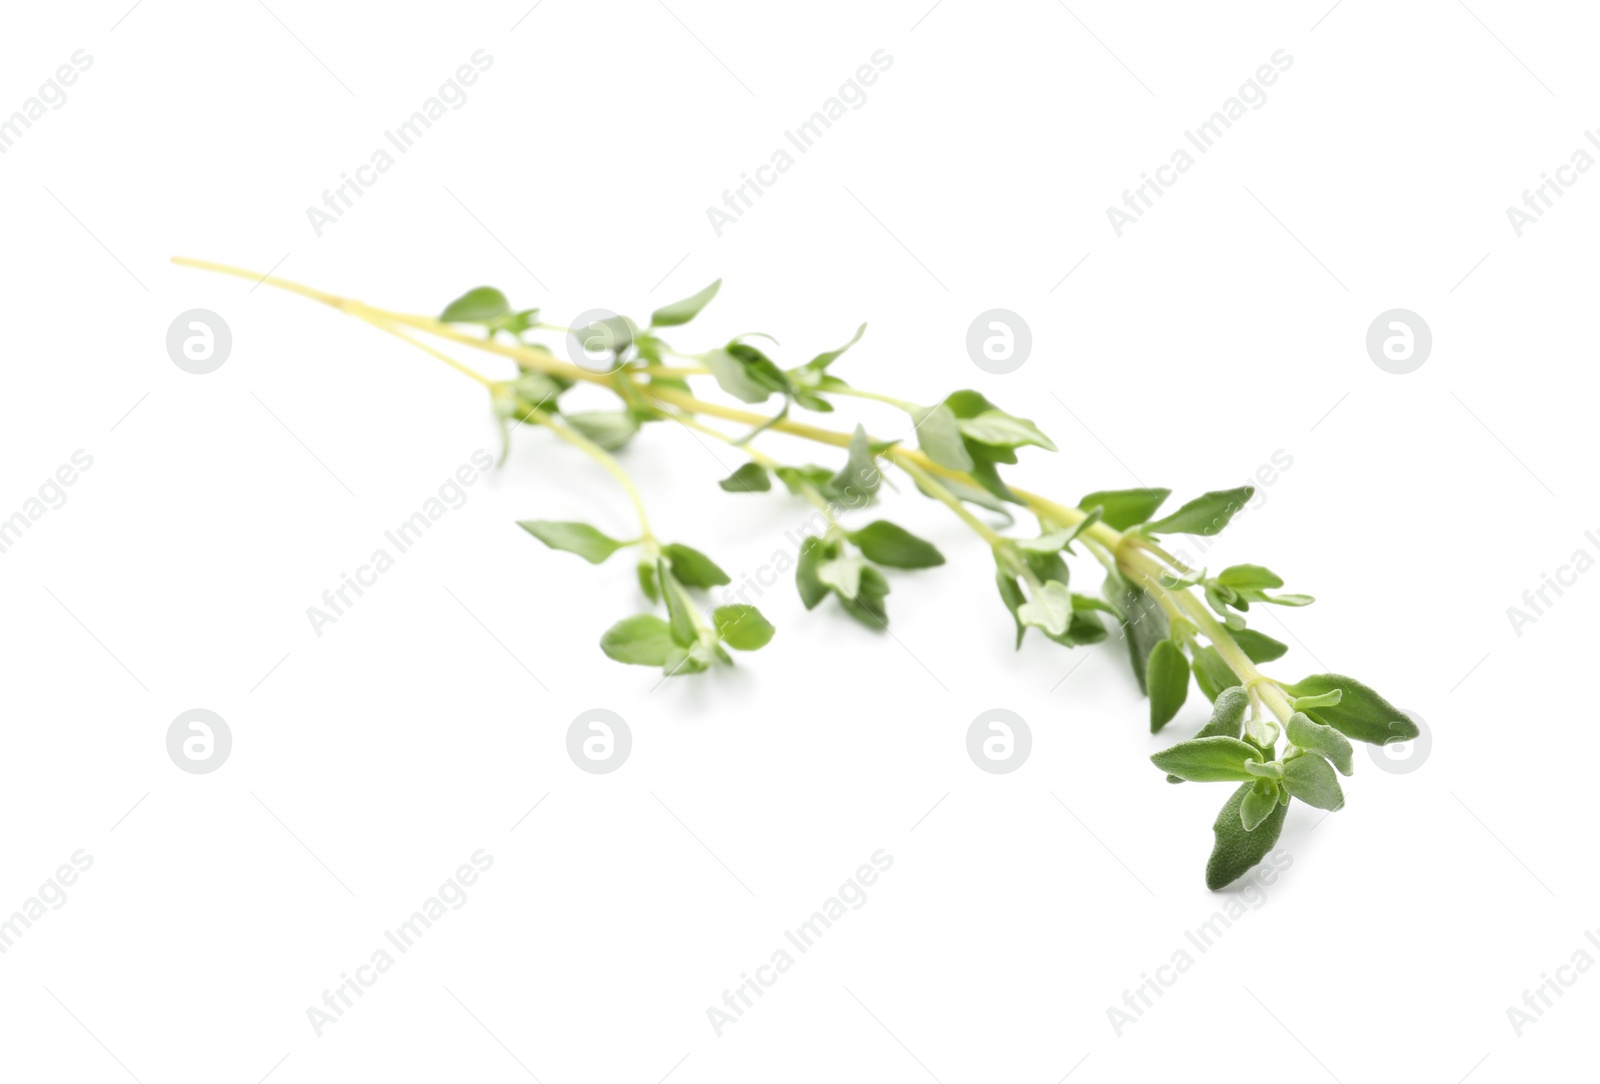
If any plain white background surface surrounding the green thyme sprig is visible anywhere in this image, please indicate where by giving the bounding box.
[0,0,1600,1084]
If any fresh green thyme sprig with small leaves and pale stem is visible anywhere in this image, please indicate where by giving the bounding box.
[174,259,1419,889]
